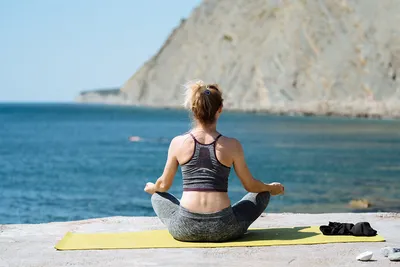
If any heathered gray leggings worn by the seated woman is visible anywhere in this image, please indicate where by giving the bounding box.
[151,192,270,242]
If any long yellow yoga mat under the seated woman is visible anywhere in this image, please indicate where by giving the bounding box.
[55,226,385,250]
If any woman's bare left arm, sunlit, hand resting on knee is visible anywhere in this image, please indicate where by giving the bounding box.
[144,137,179,194]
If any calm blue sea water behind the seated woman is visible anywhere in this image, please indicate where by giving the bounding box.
[0,104,400,224]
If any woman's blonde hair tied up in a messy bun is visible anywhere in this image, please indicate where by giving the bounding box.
[183,80,224,125]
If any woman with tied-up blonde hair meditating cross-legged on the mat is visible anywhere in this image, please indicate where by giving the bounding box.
[144,81,284,242]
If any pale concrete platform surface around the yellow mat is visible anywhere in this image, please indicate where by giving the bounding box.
[0,213,400,267]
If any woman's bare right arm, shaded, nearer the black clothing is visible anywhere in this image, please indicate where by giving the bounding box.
[233,139,284,195]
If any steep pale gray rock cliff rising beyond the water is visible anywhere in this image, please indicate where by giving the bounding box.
[76,0,400,117]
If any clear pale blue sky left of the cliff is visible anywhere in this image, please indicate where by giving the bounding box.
[0,0,201,102]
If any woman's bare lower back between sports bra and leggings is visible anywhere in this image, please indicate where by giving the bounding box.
[180,191,231,213]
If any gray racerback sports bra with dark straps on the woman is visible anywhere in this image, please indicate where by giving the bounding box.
[181,133,231,192]
